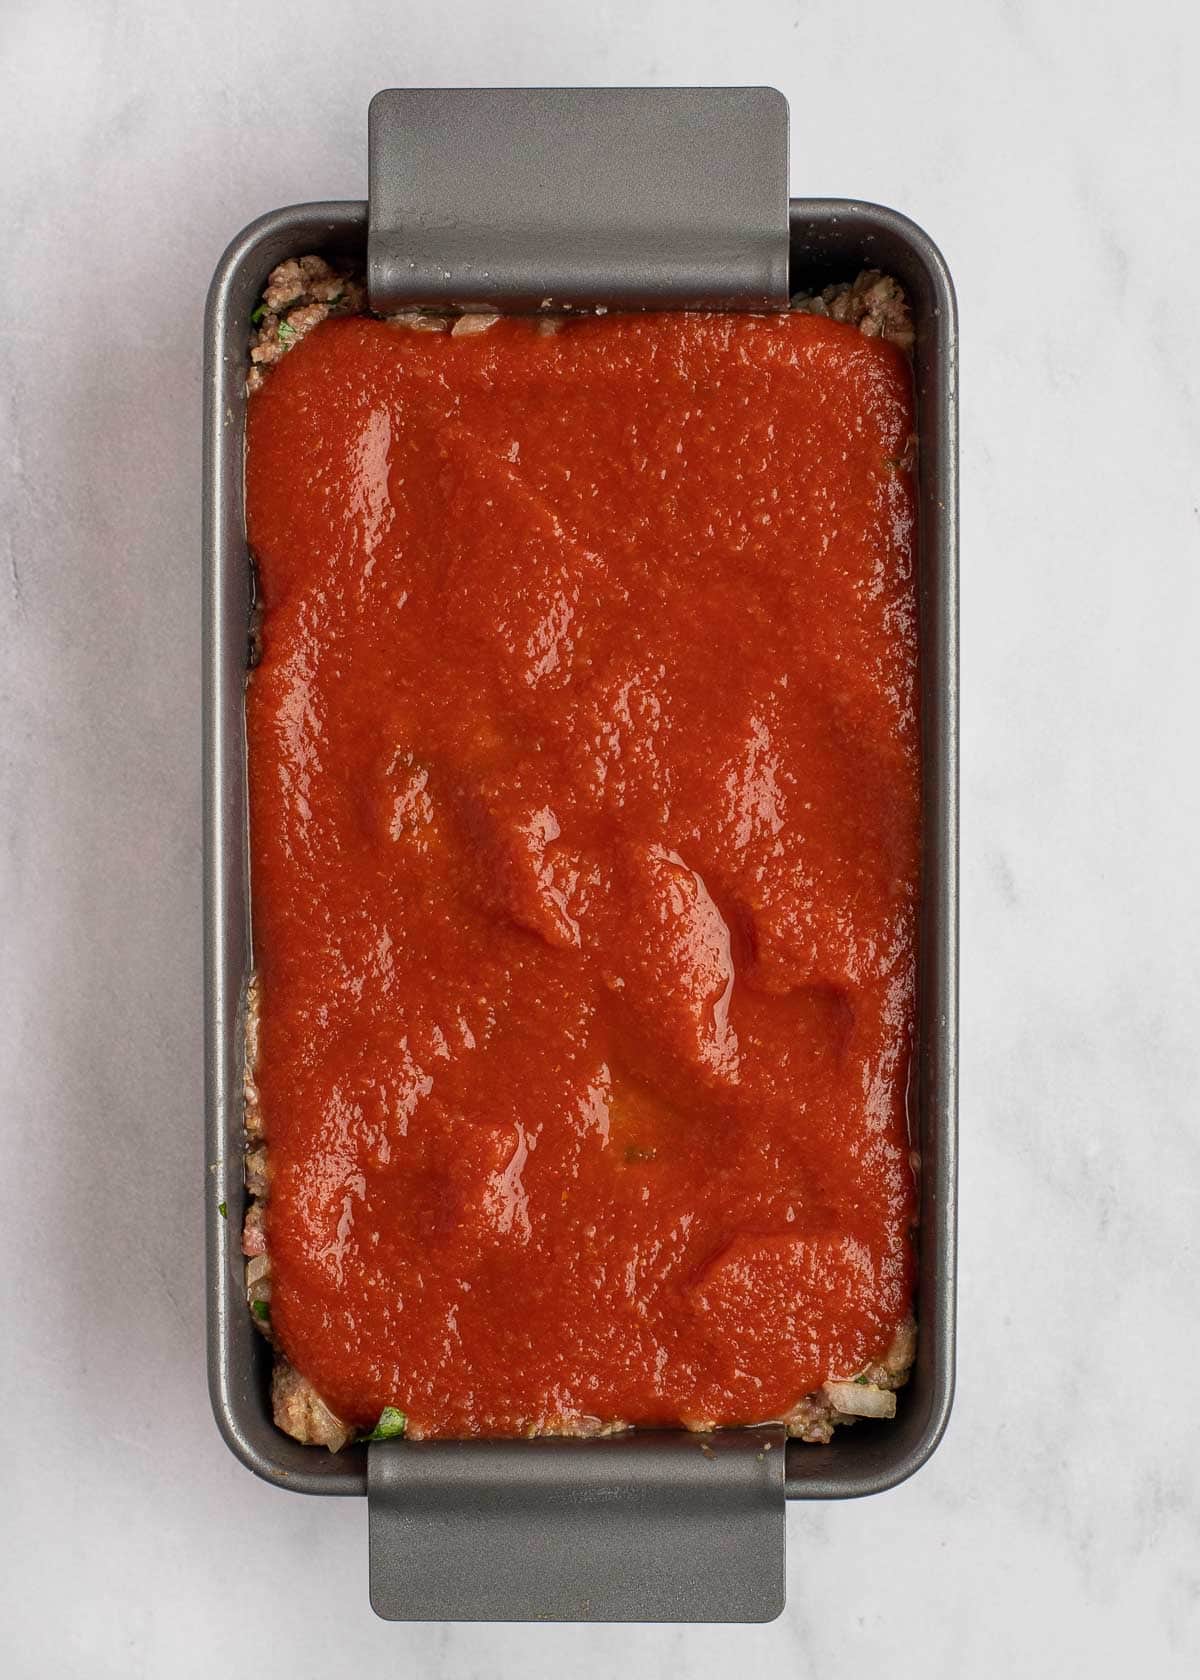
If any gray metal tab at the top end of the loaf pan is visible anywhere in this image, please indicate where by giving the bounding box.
[366,87,788,314]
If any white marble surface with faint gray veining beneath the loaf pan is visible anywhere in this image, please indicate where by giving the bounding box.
[0,0,1200,1680]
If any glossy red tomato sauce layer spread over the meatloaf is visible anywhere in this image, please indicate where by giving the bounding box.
[247,314,919,1436]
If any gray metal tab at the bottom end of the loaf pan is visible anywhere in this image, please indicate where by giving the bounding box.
[368,1425,785,1621]
